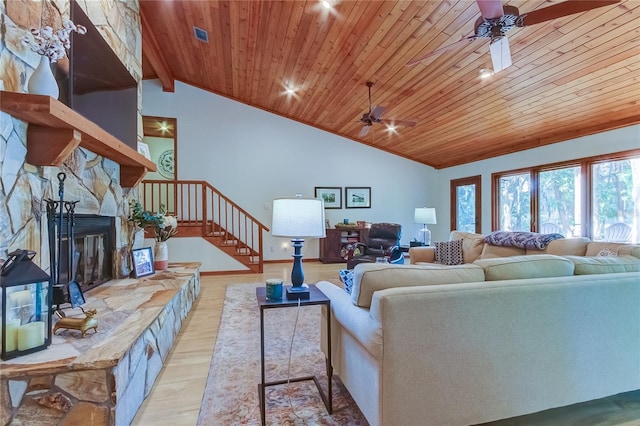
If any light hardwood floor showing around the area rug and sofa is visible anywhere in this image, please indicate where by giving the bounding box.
[133,261,640,426]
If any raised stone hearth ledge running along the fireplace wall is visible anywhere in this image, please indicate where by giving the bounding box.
[0,262,200,425]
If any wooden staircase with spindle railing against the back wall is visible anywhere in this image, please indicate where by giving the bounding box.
[140,180,269,273]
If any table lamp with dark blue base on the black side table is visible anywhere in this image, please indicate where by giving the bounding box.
[271,196,326,299]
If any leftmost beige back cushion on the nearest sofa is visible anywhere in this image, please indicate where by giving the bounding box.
[351,263,484,308]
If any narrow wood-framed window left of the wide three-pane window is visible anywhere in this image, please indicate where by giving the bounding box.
[451,176,482,234]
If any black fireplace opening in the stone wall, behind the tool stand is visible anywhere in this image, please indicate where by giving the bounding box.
[50,214,115,305]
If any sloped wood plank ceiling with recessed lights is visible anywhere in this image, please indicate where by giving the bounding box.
[140,0,640,168]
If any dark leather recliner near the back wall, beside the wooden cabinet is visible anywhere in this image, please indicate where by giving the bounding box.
[347,223,404,269]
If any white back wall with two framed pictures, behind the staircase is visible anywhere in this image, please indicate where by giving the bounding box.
[142,80,440,271]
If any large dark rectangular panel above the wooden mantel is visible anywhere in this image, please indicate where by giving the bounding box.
[56,1,138,149]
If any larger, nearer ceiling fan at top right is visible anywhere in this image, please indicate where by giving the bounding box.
[407,0,621,72]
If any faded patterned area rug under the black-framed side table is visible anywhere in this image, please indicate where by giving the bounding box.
[198,284,368,426]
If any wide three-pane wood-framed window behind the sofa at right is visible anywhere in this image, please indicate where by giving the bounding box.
[492,150,640,243]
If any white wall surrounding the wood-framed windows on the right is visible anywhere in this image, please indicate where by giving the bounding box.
[436,125,640,241]
